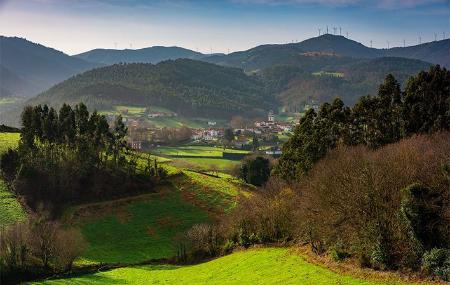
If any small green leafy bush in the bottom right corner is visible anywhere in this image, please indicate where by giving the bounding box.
[422,248,450,281]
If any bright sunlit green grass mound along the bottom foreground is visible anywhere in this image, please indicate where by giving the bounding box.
[36,248,420,285]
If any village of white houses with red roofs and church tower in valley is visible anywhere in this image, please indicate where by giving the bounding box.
[112,109,298,157]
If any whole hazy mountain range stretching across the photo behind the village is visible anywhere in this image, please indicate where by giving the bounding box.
[0,34,450,122]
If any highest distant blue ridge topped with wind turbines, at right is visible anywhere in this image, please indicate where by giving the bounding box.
[203,34,450,71]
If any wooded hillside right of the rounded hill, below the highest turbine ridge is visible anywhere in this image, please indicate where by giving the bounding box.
[258,57,431,112]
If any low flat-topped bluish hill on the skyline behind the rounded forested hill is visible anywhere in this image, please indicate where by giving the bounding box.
[74,46,205,65]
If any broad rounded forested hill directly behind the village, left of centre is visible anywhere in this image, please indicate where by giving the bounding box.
[29,59,275,117]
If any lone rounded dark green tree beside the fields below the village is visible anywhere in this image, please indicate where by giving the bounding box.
[239,156,270,186]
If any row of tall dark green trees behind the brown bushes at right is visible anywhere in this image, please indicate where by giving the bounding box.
[275,66,450,179]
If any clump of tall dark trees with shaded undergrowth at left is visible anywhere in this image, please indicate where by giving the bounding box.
[1,104,160,214]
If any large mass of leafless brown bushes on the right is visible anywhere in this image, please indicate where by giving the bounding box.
[295,133,450,269]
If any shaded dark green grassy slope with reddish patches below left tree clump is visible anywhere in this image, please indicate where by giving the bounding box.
[68,188,209,263]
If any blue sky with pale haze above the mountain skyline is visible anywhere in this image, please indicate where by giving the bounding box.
[0,0,450,55]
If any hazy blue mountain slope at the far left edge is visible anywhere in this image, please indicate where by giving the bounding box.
[0,36,98,97]
